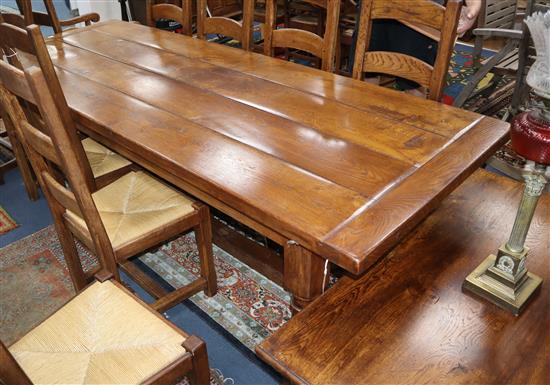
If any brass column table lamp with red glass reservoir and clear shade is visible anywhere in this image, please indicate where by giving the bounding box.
[462,12,550,315]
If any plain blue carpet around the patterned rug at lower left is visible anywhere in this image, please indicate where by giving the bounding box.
[0,169,281,385]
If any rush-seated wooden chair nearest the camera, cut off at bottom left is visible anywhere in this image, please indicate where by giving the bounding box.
[0,274,210,385]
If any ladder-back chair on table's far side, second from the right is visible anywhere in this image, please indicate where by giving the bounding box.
[264,0,340,72]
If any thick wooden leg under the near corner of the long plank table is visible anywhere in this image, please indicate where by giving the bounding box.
[284,241,328,313]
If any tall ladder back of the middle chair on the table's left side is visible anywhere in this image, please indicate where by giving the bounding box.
[0,29,118,288]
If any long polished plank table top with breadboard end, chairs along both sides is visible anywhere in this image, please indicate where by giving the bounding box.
[48,21,509,273]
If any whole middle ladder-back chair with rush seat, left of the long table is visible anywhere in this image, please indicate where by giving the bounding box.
[0,25,220,311]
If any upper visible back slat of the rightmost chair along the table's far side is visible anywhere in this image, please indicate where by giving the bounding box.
[367,0,445,29]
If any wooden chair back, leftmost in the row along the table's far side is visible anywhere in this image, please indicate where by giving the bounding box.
[146,0,193,36]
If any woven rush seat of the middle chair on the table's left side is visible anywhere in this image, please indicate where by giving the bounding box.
[66,171,195,249]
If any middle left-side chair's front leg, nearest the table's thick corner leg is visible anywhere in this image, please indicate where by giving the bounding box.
[194,203,218,297]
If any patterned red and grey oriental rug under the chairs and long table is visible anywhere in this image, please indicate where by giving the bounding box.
[0,225,291,350]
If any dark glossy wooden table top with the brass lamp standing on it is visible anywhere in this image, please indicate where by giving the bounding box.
[256,170,550,385]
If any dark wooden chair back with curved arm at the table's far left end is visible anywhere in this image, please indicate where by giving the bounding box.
[16,0,99,33]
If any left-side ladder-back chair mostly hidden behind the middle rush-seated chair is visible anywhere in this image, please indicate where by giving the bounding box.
[0,19,135,191]
